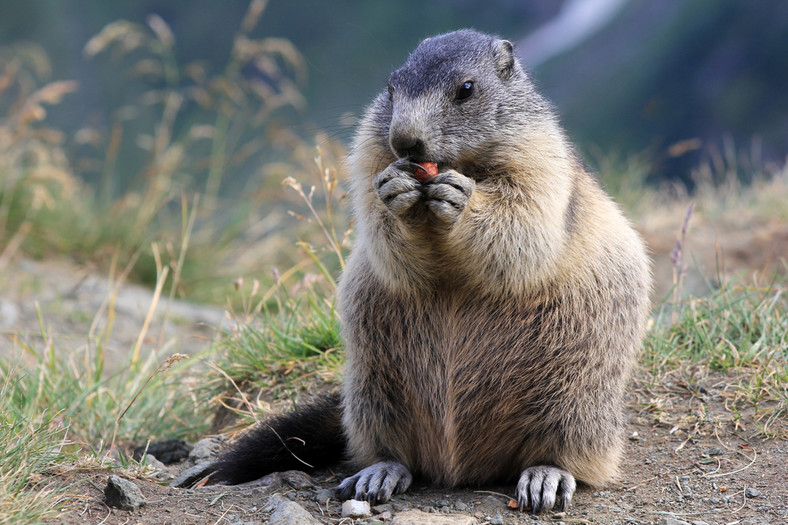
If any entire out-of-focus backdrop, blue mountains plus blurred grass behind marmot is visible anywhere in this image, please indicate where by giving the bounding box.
[0,0,788,308]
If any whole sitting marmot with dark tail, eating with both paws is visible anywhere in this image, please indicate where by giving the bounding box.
[199,30,651,512]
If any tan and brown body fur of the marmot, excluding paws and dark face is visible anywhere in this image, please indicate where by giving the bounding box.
[339,31,650,492]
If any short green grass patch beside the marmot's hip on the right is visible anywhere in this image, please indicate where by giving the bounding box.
[641,277,788,439]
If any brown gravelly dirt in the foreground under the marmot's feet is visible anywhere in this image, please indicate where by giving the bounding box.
[47,376,788,525]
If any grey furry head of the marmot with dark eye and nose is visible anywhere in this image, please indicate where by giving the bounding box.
[372,29,550,178]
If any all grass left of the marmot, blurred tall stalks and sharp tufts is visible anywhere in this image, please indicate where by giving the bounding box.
[0,0,346,523]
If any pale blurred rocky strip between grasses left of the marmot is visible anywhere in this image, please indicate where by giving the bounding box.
[0,259,229,370]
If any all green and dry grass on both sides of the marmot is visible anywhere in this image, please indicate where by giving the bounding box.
[0,0,788,524]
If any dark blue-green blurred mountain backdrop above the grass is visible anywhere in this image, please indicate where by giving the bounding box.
[6,0,788,191]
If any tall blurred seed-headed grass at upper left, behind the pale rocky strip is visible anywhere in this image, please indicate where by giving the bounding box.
[0,0,343,304]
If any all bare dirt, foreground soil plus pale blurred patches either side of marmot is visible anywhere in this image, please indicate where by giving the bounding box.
[0,199,788,525]
